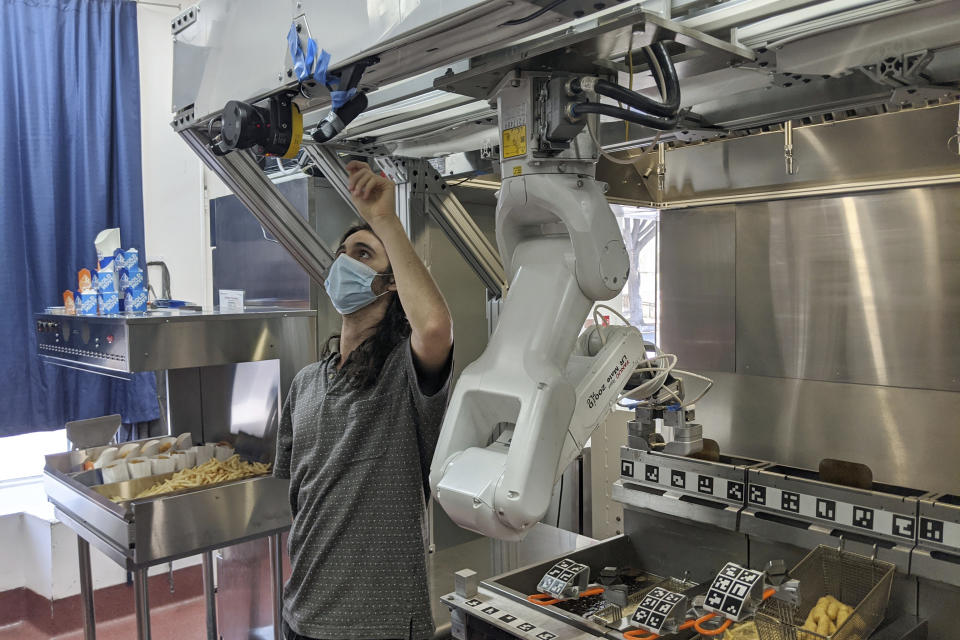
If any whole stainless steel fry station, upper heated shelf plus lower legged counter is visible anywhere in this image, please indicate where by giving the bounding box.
[35,307,317,640]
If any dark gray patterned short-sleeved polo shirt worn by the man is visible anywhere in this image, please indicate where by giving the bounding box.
[274,339,452,640]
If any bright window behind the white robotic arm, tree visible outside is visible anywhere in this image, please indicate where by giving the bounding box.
[584,205,660,343]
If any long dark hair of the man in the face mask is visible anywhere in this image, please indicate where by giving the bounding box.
[320,224,410,389]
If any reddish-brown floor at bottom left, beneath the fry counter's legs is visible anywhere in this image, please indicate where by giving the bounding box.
[0,597,206,640]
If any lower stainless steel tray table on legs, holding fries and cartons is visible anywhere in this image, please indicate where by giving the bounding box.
[44,440,291,640]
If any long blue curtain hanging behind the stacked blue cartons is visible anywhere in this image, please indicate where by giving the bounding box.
[0,0,160,435]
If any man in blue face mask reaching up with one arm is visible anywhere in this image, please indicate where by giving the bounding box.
[274,162,453,640]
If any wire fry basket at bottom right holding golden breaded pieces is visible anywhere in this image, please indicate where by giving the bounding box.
[756,545,895,640]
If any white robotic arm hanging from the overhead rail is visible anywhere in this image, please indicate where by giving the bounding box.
[430,76,664,540]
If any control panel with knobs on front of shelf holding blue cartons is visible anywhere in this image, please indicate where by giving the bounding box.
[35,314,129,373]
